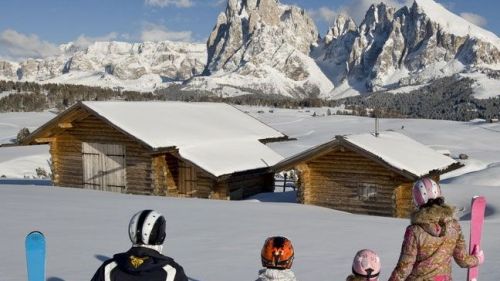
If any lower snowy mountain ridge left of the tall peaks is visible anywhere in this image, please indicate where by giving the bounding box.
[0,41,207,91]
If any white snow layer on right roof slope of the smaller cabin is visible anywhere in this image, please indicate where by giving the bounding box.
[343,131,457,177]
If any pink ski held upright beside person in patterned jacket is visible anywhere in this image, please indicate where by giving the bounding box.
[467,196,486,281]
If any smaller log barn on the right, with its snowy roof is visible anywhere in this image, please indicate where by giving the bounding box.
[274,131,460,217]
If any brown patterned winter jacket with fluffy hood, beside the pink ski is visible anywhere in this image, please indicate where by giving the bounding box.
[389,204,478,281]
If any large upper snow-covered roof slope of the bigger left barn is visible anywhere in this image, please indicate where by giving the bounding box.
[82,101,284,149]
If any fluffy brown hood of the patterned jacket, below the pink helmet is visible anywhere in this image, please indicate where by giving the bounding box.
[411,204,455,237]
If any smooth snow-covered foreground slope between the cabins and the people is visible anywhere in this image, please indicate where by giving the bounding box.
[0,180,500,281]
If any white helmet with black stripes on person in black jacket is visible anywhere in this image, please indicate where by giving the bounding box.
[128,210,166,245]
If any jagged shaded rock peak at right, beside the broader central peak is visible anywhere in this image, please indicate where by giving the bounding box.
[313,0,500,91]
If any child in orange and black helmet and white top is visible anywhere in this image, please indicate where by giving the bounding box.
[257,236,297,281]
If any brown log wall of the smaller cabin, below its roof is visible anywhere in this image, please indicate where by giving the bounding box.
[296,147,411,216]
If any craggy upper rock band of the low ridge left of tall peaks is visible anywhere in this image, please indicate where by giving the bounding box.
[5,42,206,81]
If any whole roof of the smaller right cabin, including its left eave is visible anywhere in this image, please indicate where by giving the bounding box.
[275,131,458,178]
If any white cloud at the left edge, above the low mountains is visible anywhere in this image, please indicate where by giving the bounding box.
[0,29,60,60]
